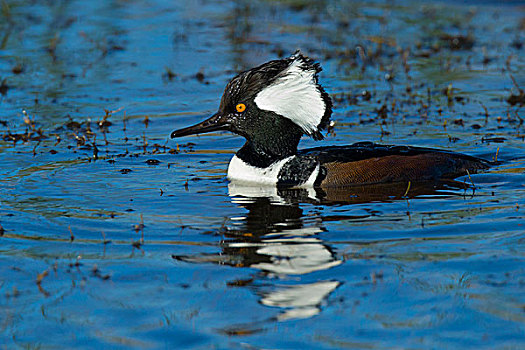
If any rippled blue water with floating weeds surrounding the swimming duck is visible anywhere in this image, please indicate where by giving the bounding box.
[0,0,525,349]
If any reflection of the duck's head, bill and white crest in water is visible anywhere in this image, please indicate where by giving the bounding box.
[174,192,342,320]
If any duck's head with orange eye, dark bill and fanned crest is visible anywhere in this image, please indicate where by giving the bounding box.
[171,52,332,148]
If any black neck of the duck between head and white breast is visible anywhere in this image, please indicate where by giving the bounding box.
[236,133,301,168]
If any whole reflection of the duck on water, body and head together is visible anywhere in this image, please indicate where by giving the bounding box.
[173,182,466,320]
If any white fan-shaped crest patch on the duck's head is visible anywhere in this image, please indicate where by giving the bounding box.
[255,56,326,134]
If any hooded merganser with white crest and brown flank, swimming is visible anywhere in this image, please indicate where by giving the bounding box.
[171,52,490,187]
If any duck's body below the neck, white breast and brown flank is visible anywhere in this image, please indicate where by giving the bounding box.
[228,142,489,187]
